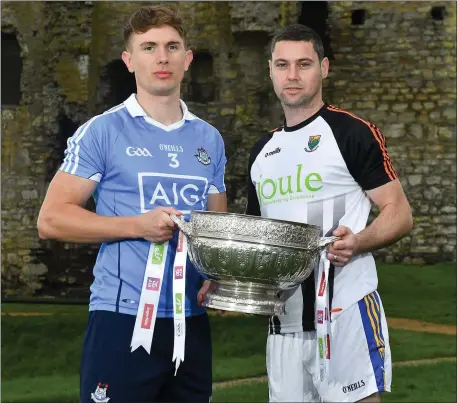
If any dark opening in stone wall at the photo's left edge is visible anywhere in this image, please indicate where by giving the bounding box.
[1,32,22,106]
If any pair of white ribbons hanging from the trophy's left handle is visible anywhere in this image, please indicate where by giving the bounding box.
[130,227,187,375]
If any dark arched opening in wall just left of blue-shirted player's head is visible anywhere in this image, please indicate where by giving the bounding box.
[98,60,136,112]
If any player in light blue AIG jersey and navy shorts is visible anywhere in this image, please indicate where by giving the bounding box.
[38,6,227,403]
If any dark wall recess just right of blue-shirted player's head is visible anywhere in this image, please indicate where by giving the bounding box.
[188,52,216,103]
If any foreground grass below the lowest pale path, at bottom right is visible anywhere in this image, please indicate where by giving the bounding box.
[213,362,456,403]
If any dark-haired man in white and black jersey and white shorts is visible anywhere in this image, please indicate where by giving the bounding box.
[246,24,412,402]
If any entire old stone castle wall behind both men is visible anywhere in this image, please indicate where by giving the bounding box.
[1,1,456,298]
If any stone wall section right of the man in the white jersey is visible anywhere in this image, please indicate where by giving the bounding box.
[327,2,456,263]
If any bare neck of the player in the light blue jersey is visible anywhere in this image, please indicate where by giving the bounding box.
[136,88,183,126]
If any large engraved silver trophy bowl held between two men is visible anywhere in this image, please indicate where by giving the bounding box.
[170,210,339,316]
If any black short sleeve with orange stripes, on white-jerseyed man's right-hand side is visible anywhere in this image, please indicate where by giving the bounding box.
[343,123,398,190]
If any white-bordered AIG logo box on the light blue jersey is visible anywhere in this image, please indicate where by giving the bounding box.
[138,172,208,213]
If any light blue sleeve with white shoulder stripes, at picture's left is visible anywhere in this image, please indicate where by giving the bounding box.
[60,118,105,182]
